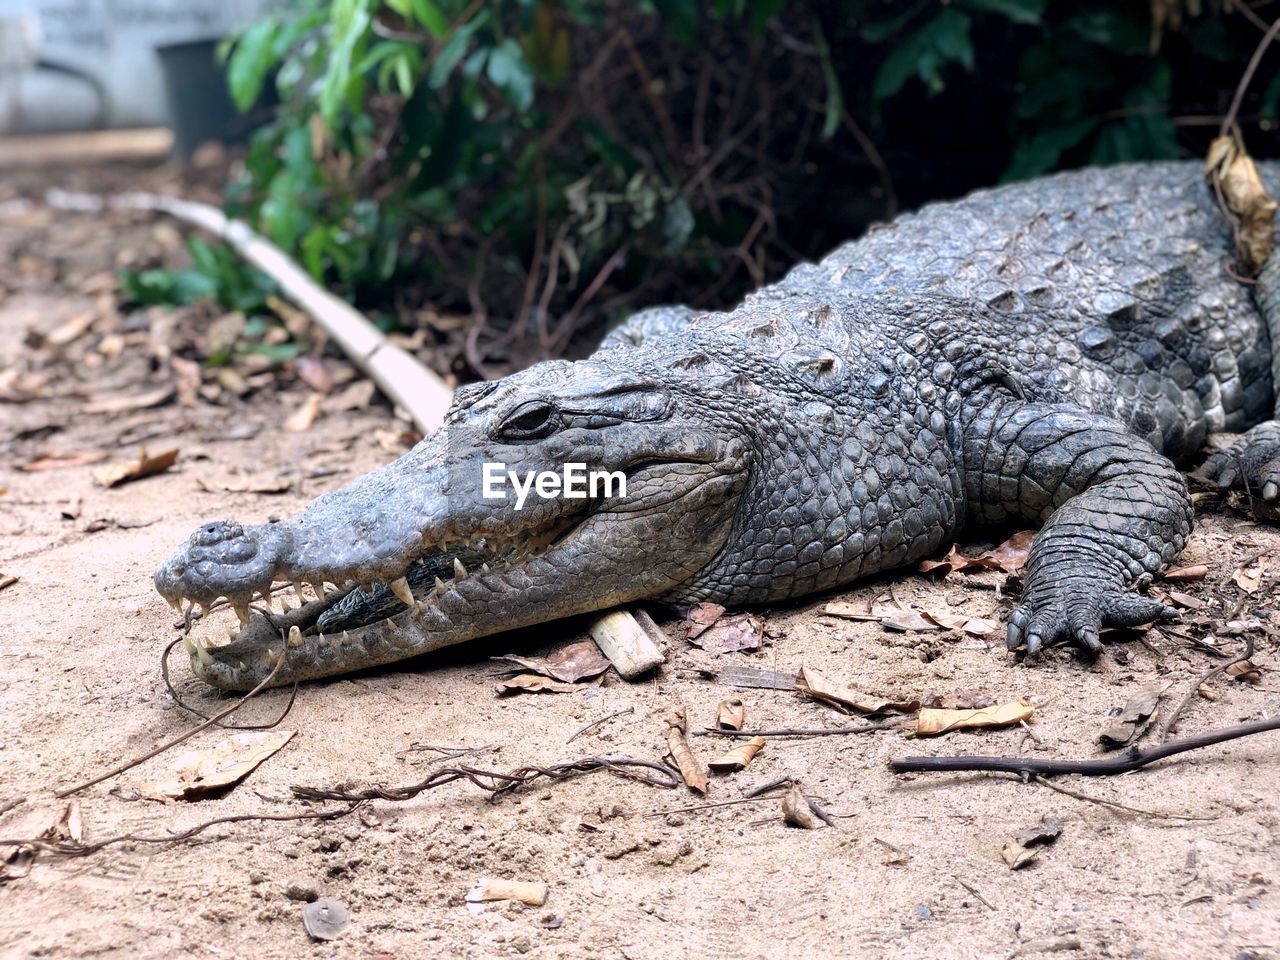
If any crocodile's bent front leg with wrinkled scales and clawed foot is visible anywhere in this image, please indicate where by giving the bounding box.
[965,401,1192,654]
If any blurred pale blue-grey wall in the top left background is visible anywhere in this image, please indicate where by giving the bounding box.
[0,0,279,133]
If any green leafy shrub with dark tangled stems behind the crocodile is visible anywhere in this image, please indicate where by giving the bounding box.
[149,0,1280,374]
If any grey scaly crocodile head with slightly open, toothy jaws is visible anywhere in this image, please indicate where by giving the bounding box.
[155,360,750,690]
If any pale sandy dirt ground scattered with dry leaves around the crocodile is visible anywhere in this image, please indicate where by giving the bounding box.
[0,161,1280,959]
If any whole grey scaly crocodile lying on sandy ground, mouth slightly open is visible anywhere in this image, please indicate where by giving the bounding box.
[155,161,1280,690]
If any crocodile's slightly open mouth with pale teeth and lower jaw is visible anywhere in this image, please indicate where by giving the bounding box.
[156,500,598,690]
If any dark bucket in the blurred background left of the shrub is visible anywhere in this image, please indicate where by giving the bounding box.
[156,37,276,159]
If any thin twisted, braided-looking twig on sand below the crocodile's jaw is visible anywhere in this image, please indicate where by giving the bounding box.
[291,756,684,803]
